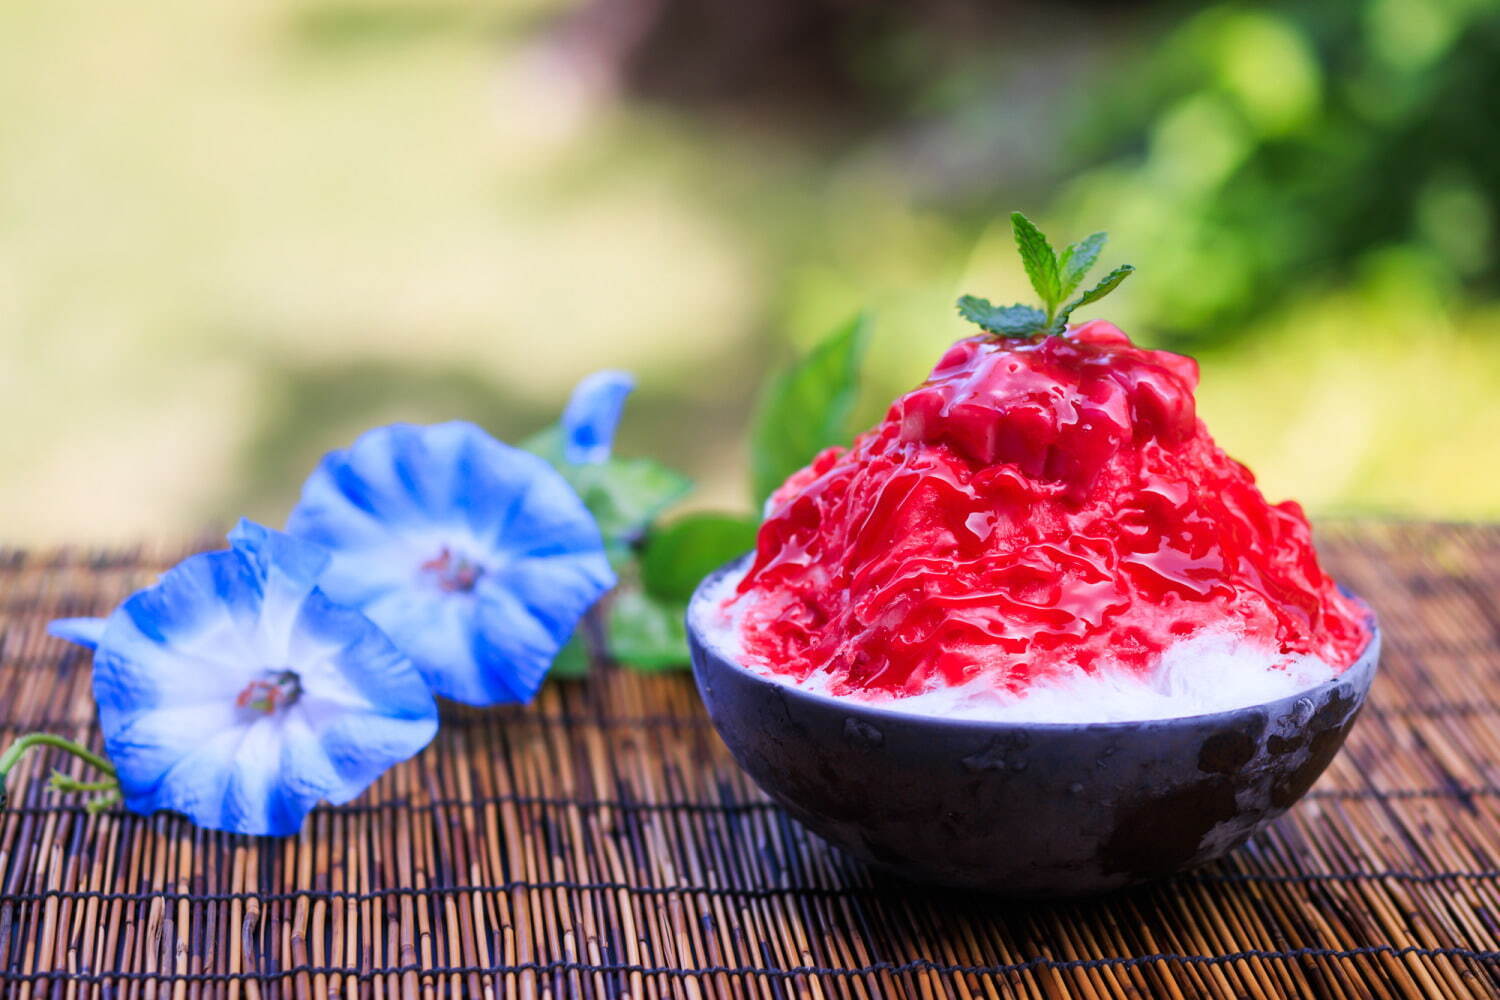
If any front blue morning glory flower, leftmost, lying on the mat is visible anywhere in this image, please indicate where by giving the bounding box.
[50,520,438,835]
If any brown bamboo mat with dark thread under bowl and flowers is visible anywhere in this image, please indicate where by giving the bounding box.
[0,523,1500,1000]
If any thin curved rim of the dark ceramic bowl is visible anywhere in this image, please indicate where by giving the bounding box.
[684,550,1382,733]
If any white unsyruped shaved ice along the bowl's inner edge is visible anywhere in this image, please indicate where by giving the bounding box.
[693,570,1335,723]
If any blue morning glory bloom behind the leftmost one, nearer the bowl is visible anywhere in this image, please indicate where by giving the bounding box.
[287,421,615,705]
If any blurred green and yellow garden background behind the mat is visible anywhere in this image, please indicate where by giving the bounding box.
[0,0,1500,543]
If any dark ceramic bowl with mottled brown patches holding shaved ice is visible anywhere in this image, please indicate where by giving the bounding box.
[687,559,1380,897]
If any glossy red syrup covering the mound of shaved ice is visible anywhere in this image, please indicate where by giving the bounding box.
[738,321,1368,694]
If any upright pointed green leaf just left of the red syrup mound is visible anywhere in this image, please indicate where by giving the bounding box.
[750,315,870,505]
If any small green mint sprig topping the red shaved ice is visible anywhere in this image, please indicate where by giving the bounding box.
[959,211,1136,337]
